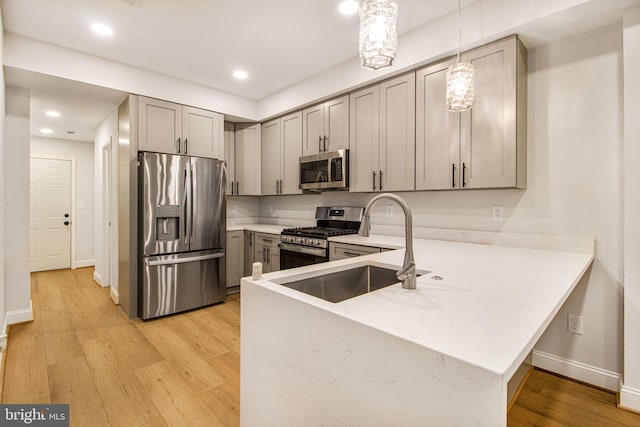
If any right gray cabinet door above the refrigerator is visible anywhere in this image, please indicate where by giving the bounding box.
[182,106,224,159]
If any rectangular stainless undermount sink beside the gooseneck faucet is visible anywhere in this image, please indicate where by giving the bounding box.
[278,265,422,302]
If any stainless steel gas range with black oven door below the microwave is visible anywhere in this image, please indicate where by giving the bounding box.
[278,206,364,270]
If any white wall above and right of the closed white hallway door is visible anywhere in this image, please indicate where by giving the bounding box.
[31,136,95,267]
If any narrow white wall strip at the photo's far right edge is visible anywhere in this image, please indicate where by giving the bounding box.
[620,3,640,411]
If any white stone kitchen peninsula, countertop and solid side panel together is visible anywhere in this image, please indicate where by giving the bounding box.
[241,236,593,426]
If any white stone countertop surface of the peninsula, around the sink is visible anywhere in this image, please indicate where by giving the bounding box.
[243,237,593,383]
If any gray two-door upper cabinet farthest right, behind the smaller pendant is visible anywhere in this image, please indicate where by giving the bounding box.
[416,36,527,190]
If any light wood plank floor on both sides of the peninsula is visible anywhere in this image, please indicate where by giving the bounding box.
[2,268,640,427]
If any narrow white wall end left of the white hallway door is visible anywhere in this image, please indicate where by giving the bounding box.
[2,86,32,324]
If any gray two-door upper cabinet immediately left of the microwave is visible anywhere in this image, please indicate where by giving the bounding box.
[262,111,302,195]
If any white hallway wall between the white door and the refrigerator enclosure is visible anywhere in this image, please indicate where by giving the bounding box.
[93,105,118,300]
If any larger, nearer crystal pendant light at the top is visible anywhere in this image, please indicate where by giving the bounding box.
[360,0,398,70]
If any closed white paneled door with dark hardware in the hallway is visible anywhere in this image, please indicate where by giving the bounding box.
[29,157,72,271]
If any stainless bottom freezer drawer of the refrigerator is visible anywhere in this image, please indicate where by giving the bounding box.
[138,250,226,320]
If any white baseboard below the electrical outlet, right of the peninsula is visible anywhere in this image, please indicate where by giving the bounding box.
[533,350,620,392]
